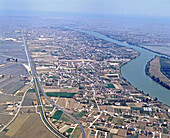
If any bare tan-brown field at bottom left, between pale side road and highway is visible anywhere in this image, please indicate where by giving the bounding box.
[5,113,55,138]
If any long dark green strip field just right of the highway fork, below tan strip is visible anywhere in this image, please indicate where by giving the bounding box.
[46,92,76,98]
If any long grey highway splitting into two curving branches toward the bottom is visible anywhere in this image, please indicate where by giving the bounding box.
[22,31,86,138]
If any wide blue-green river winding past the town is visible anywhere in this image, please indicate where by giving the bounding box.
[75,29,170,106]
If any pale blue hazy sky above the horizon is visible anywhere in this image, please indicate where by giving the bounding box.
[0,0,170,17]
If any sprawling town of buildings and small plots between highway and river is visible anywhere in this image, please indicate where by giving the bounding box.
[23,27,170,137]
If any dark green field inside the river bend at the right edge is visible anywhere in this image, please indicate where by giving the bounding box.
[160,57,170,79]
